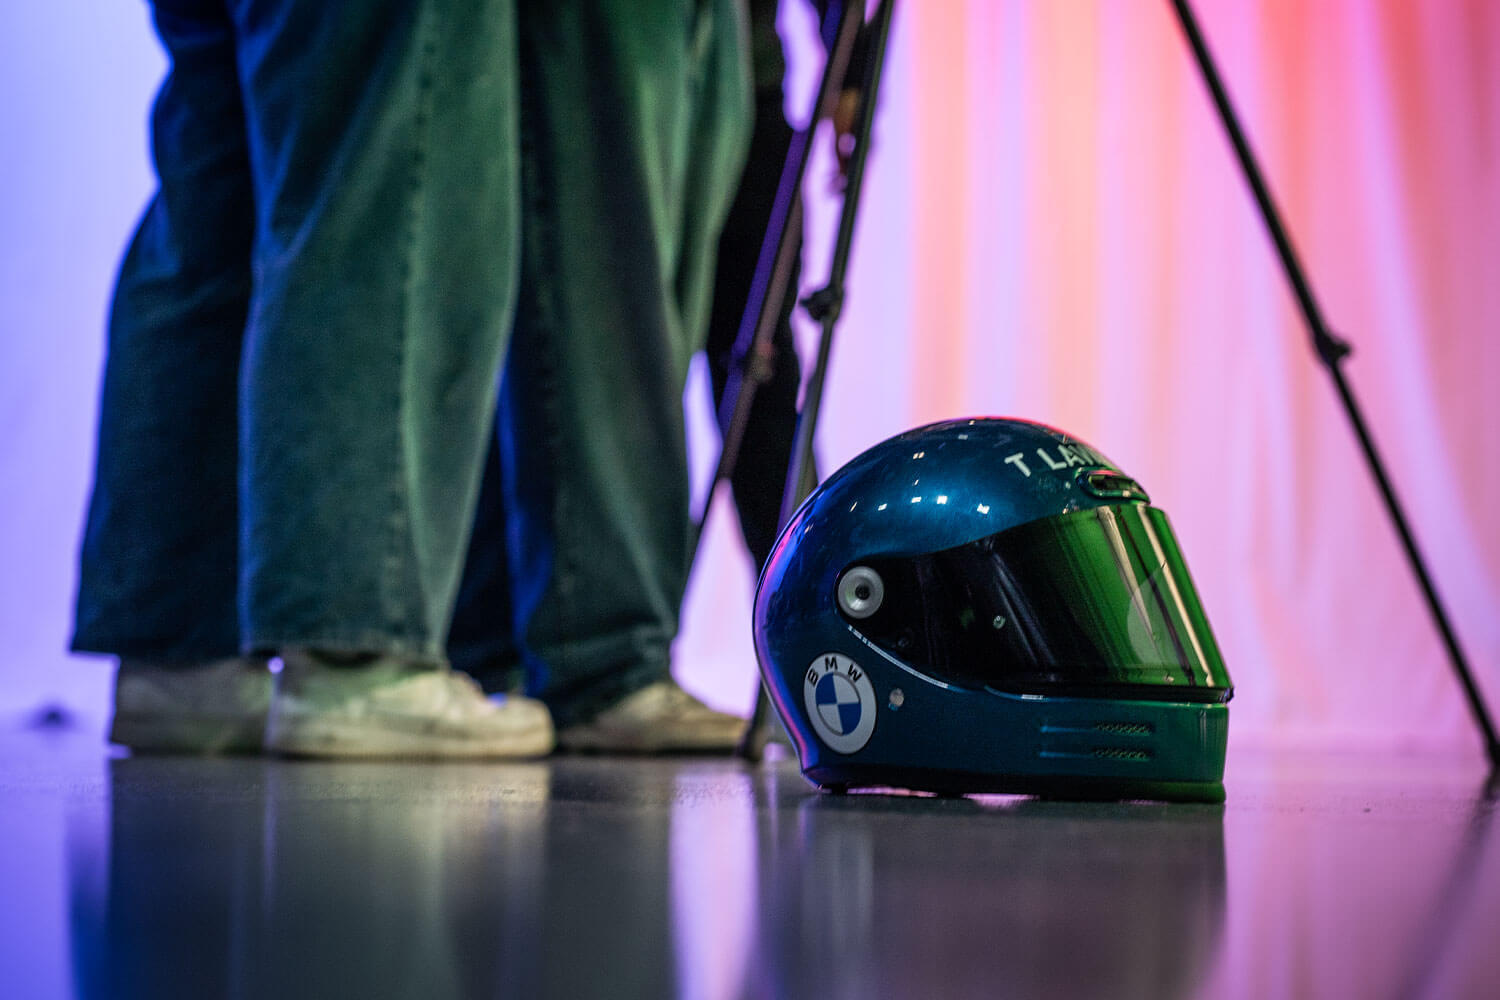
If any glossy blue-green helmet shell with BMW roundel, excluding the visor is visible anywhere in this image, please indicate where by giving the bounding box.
[753,418,1229,799]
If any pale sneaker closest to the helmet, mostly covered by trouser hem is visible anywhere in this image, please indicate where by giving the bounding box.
[558,681,746,754]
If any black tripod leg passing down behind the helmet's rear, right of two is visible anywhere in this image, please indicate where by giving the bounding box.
[740,0,896,760]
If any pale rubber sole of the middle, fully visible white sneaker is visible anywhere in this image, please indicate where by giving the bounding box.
[266,717,555,760]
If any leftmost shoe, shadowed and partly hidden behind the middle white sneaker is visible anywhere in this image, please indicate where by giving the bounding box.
[110,657,272,754]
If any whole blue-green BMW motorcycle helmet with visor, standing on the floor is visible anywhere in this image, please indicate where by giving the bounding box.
[755,418,1233,802]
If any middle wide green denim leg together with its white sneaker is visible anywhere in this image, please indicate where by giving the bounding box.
[222,0,552,757]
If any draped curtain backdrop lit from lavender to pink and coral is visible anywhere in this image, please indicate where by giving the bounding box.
[0,0,1500,748]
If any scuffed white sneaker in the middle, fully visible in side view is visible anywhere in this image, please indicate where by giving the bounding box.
[266,649,554,757]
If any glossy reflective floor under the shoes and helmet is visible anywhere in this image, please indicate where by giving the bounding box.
[0,724,1500,1000]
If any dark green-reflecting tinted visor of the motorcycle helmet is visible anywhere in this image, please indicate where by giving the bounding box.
[843,504,1232,702]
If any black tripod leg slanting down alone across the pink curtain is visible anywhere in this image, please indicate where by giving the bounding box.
[1172,0,1500,769]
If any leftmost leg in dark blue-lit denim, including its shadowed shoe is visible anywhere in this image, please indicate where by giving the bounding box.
[72,3,272,753]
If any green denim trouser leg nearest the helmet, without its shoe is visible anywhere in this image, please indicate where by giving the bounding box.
[500,0,750,726]
